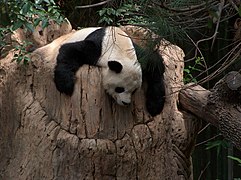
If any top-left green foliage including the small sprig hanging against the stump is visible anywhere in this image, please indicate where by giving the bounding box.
[0,0,64,64]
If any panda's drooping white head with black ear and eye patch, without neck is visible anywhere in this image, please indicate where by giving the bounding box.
[103,61,142,105]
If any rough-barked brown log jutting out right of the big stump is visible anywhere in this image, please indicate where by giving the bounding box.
[180,79,241,150]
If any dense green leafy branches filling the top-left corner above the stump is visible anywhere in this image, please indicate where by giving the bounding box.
[0,0,63,31]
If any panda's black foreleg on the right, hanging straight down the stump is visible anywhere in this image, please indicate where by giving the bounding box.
[134,44,165,116]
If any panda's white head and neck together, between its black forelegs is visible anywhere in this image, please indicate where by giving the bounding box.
[98,27,142,105]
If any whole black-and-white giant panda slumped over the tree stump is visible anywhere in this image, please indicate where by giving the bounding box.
[38,27,165,116]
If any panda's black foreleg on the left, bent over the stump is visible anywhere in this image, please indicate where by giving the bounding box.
[54,28,105,95]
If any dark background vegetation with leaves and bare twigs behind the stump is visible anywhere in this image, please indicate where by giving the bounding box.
[0,0,241,179]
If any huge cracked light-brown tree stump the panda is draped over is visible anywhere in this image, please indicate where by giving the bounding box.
[0,27,200,180]
